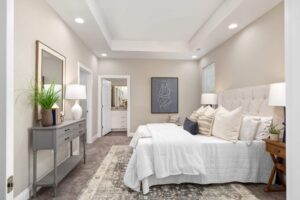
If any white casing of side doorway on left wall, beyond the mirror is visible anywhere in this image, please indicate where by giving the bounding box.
[77,62,93,144]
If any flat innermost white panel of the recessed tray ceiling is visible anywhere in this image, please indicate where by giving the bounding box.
[96,0,223,42]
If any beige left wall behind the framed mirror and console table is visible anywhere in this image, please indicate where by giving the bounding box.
[14,0,98,196]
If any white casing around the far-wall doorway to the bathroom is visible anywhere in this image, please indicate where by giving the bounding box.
[98,75,131,137]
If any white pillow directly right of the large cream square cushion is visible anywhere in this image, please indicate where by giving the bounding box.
[240,115,260,142]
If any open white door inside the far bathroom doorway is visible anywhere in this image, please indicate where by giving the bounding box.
[101,80,111,135]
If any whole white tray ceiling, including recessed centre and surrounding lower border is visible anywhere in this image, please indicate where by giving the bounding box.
[47,0,282,60]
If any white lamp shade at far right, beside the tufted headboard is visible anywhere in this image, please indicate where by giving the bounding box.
[269,82,286,106]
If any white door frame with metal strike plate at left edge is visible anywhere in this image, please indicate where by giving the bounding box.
[0,0,15,200]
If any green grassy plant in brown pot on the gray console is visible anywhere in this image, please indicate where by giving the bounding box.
[31,83,60,126]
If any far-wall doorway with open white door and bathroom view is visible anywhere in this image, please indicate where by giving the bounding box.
[98,75,130,136]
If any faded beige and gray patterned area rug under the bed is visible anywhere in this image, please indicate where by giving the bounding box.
[79,146,257,200]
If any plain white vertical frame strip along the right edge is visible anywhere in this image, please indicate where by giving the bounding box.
[284,0,300,200]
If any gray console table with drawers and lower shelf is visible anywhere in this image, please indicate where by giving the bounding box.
[32,119,86,197]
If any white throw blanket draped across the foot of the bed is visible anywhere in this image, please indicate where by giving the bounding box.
[136,123,205,178]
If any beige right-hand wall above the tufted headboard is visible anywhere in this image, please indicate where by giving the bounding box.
[200,3,284,91]
